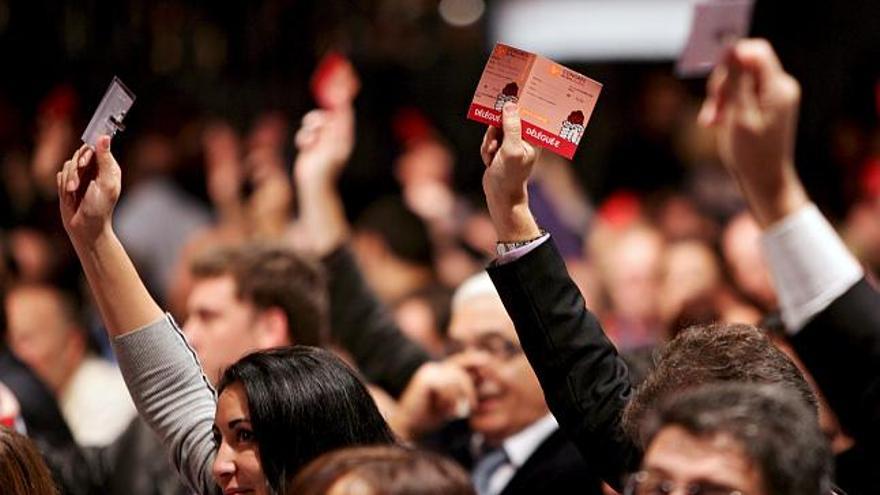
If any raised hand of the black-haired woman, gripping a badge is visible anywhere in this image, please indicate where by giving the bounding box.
[56,136,122,245]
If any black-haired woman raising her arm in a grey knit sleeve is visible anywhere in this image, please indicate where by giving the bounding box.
[57,136,394,495]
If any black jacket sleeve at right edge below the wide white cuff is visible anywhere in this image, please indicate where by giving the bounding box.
[791,278,880,444]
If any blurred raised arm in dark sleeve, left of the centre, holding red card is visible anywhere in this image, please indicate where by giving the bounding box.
[293,105,430,397]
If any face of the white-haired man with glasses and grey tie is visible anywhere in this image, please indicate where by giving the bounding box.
[449,295,548,445]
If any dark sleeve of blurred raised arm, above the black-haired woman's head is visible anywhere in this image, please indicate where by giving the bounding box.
[323,247,430,397]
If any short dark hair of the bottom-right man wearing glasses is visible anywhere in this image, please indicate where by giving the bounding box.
[645,383,832,495]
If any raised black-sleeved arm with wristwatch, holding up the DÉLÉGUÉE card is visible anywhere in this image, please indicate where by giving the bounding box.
[481,103,641,489]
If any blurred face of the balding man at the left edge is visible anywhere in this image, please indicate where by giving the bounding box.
[6,288,84,393]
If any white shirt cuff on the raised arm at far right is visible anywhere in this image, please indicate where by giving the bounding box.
[761,204,864,335]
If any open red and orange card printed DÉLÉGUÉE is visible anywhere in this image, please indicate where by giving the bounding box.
[468,43,602,159]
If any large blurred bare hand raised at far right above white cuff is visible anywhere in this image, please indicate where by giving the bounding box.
[699,40,808,227]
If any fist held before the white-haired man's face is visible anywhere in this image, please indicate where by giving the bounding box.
[399,361,477,437]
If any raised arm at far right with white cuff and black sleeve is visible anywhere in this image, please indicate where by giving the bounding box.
[700,40,880,442]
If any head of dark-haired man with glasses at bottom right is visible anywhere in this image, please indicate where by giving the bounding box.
[624,383,831,495]
